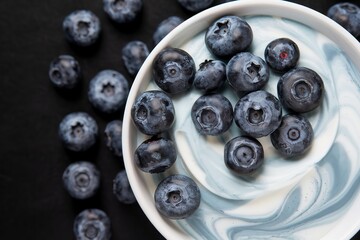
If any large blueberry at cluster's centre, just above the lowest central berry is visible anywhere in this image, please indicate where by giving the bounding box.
[234,90,282,138]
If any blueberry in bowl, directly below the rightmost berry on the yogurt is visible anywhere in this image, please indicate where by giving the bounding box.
[270,114,314,157]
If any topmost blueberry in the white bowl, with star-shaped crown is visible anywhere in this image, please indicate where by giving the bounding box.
[205,16,253,59]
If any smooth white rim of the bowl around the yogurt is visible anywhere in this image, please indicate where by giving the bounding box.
[122,0,360,239]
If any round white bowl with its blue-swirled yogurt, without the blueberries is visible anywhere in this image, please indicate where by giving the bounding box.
[123,0,360,239]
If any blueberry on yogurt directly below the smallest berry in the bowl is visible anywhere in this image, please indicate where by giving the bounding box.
[191,93,233,136]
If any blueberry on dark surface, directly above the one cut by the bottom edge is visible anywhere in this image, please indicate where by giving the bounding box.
[62,161,100,199]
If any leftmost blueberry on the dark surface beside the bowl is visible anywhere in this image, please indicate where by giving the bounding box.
[49,55,81,89]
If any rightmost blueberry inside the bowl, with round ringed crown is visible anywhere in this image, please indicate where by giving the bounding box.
[277,67,325,113]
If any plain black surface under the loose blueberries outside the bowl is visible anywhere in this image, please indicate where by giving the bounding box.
[0,0,360,240]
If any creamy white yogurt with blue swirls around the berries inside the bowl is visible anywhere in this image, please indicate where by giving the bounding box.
[133,16,360,239]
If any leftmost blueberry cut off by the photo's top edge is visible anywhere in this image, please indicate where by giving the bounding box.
[103,0,143,24]
